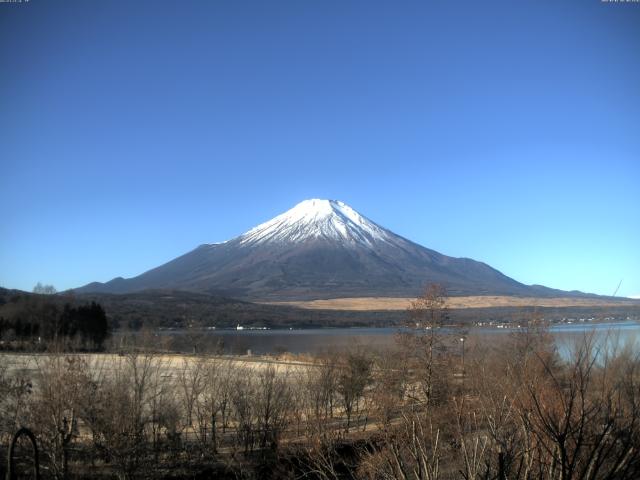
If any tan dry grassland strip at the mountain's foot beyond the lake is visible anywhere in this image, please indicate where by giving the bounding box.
[265,296,640,311]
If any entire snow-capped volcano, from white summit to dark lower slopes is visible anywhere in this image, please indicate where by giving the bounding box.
[79,199,592,300]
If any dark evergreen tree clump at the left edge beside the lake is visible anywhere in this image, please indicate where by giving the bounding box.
[0,294,110,350]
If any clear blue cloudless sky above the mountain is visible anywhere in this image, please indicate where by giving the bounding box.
[0,0,640,295]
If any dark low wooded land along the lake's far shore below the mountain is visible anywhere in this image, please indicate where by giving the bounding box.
[0,288,640,338]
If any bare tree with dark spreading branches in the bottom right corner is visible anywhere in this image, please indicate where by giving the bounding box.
[521,337,640,480]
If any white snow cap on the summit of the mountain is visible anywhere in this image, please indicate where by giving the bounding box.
[239,199,393,246]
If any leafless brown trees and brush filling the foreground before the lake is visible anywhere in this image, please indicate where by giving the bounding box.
[0,324,640,480]
